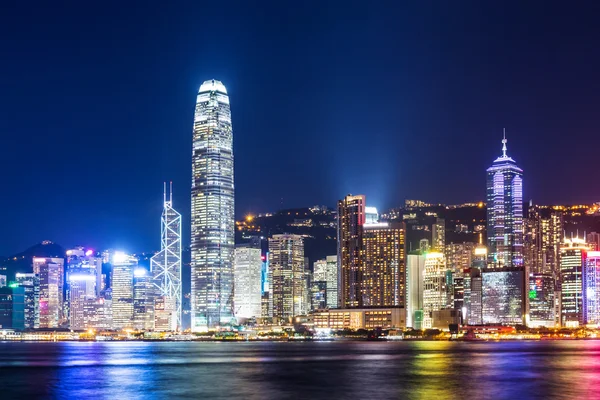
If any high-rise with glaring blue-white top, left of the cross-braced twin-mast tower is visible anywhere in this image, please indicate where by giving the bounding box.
[111,252,138,329]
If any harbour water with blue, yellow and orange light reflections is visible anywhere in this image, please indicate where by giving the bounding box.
[0,341,600,400]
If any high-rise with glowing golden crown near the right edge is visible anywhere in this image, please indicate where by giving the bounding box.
[560,238,589,327]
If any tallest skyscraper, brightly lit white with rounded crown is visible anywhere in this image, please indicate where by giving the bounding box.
[191,79,235,332]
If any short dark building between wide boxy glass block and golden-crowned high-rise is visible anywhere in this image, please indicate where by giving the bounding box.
[528,273,556,328]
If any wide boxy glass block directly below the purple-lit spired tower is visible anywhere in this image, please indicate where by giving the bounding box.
[480,267,526,325]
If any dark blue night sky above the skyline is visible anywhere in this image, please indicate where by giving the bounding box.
[0,1,600,255]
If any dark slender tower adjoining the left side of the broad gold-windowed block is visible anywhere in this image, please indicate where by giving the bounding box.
[338,195,365,308]
